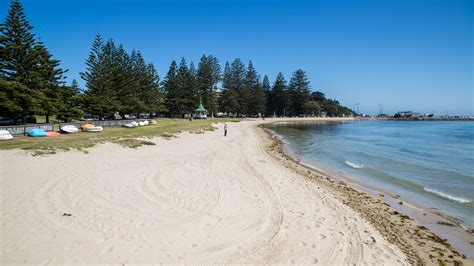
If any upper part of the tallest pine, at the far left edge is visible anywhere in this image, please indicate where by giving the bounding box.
[0,0,36,84]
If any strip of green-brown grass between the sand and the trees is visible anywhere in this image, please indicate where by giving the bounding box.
[0,118,239,155]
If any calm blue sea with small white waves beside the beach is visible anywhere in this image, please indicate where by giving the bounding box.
[268,121,474,227]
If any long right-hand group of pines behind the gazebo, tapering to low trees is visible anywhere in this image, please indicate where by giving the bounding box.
[161,58,352,117]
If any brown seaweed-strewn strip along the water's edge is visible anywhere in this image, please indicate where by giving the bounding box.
[259,120,474,264]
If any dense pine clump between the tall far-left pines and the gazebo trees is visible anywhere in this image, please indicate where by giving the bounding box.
[81,34,166,117]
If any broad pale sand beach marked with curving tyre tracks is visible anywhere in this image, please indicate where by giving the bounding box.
[0,121,406,265]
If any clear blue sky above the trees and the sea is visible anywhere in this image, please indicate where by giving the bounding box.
[0,0,474,115]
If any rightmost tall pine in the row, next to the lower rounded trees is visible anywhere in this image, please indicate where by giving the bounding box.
[288,69,311,116]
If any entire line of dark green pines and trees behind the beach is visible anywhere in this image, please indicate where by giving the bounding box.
[0,0,352,122]
